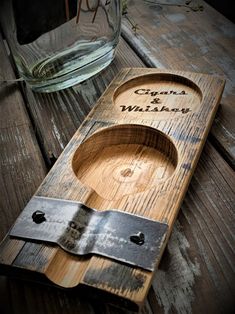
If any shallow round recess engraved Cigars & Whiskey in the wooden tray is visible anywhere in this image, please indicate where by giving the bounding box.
[113,73,202,120]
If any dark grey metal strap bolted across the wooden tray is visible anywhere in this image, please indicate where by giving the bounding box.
[10,196,168,271]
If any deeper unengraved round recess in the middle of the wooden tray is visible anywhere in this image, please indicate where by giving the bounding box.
[72,124,177,200]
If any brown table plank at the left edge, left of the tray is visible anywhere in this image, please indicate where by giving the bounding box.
[0,35,46,239]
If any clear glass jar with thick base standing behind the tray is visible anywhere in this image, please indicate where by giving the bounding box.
[0,0,121,92]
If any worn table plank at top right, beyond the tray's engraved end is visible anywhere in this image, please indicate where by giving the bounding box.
[122,0,235,167]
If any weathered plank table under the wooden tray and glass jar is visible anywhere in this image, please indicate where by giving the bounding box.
[0,0,235,314]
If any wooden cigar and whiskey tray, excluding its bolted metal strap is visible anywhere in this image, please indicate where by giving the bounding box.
[0,68,225,310]
